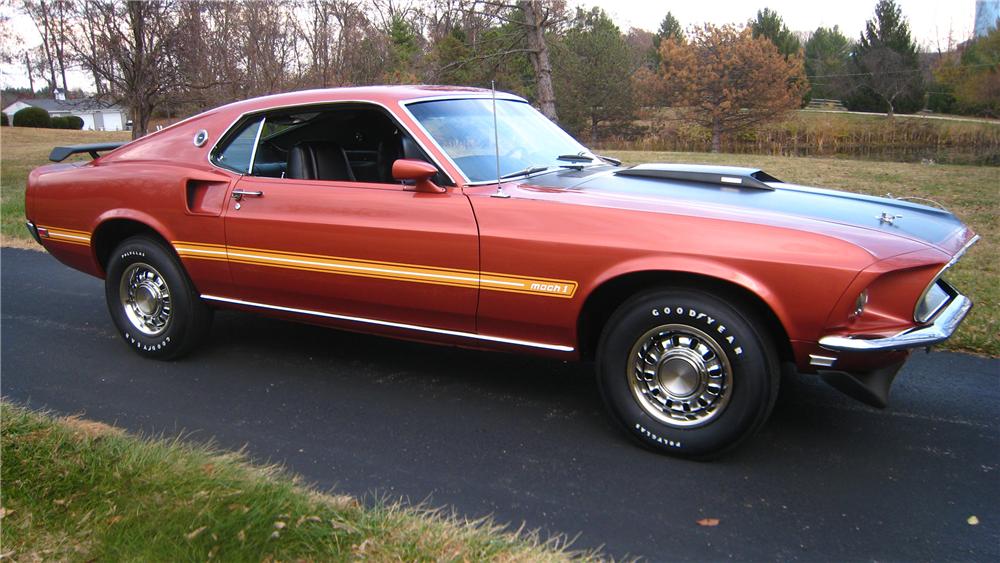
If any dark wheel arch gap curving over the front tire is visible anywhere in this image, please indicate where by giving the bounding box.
[577,270,794,361]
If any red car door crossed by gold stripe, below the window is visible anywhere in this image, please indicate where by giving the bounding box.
[225,109,479,333]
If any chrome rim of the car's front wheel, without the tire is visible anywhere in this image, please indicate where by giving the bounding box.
[626,324,733,428]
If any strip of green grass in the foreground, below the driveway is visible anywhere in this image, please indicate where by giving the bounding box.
[0,402,598,561]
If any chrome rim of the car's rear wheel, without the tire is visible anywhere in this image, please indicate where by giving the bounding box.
[118,262,172,336]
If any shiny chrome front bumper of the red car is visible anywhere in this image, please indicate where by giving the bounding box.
[819,294,972,352]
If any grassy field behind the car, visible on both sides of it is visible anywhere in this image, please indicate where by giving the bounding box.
[0,128,1000,356]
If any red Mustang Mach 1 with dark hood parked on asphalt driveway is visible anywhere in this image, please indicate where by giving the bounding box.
[25,86,978,457]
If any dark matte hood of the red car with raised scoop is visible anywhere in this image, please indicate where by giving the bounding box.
[519,165,972,254]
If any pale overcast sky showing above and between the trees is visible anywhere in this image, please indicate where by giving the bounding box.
[0,0,976,90]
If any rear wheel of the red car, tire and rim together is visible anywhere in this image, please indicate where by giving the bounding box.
[104,236,212,360]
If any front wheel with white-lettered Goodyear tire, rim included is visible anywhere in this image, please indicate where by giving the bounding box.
[597,289,780,459]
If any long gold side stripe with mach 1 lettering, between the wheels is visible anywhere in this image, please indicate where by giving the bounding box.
[173,241,577,299]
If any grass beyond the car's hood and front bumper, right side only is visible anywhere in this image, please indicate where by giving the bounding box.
[606,151,1000,356]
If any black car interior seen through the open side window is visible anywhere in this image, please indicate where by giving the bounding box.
[238,105,453,185]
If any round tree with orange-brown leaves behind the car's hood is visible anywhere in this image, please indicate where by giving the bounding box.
[657,24,808,152]
